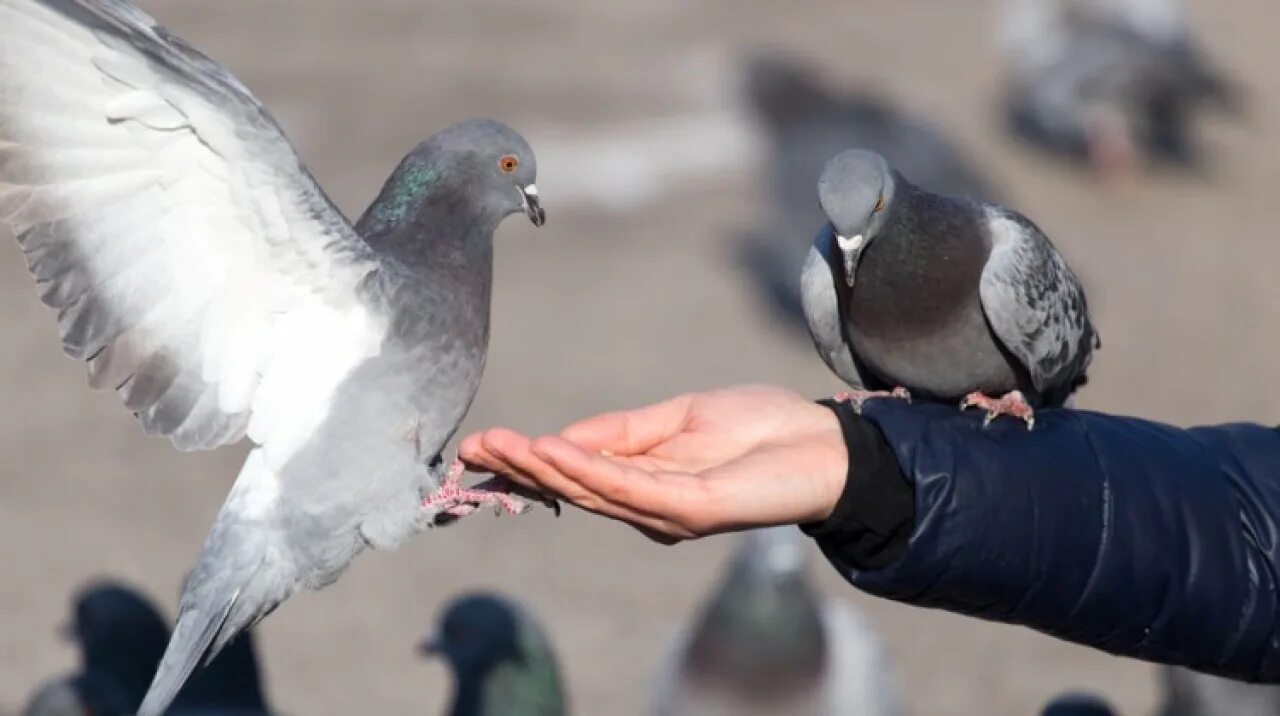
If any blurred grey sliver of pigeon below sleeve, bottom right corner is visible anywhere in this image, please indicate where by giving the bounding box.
[1158,666,1280,716]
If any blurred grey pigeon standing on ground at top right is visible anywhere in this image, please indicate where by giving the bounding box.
[1004,0,1240,174]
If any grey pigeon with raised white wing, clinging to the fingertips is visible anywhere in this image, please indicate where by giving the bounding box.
[0,0,545,716]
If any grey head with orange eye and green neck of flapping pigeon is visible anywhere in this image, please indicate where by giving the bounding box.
[356,119,547,249]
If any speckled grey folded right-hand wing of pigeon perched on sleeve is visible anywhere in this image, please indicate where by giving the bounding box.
[979,206,1101,402]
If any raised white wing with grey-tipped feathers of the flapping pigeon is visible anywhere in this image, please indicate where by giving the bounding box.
[0,0,380,450]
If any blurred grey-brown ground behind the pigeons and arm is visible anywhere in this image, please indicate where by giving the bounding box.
[0,0,1280,716]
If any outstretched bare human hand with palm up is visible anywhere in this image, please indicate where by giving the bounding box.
[460,386,849,543]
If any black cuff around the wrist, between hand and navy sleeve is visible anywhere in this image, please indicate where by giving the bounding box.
[800,400,915,570]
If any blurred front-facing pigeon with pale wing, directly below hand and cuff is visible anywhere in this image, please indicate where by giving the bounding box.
[653,526,902,716]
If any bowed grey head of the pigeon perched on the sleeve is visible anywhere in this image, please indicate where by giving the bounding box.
[818,149,895,286]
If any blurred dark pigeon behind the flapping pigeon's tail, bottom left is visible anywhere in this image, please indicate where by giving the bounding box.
[24,582,269,716]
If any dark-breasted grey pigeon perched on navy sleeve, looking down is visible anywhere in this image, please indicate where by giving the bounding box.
[801,150,1098,427]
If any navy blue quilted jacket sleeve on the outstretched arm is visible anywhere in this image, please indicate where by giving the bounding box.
[812,400,1280,681]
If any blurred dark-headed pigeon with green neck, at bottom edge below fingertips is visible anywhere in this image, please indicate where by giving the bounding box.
[421,593,567,716]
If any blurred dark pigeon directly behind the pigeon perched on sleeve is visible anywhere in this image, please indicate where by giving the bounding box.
[735,55,996,328]
